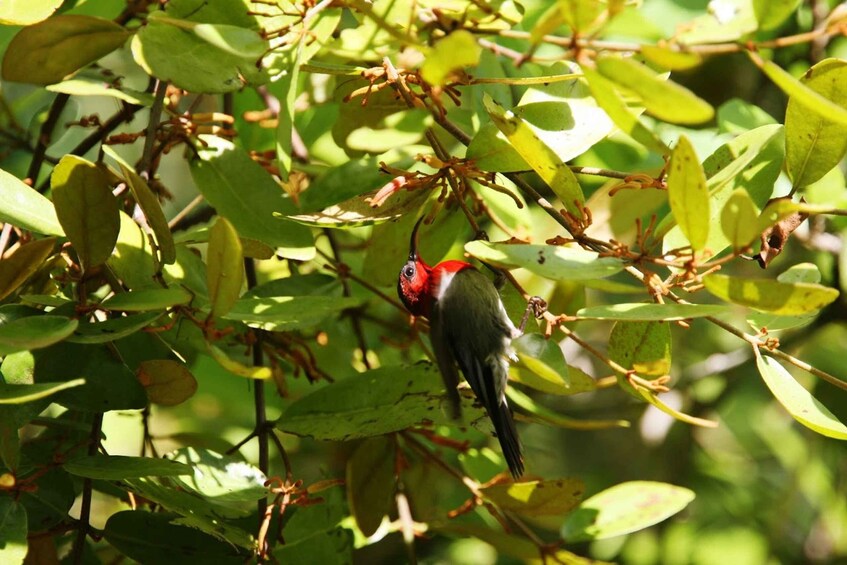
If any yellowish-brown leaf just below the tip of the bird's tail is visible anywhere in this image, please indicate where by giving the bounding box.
[480,479,585,516]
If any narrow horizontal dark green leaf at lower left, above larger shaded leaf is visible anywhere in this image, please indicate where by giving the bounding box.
[62,455,194,481]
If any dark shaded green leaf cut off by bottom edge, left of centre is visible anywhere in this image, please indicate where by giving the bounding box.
[103,510,249,565]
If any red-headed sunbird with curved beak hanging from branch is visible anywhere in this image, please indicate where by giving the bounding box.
[397,218,524,478]
